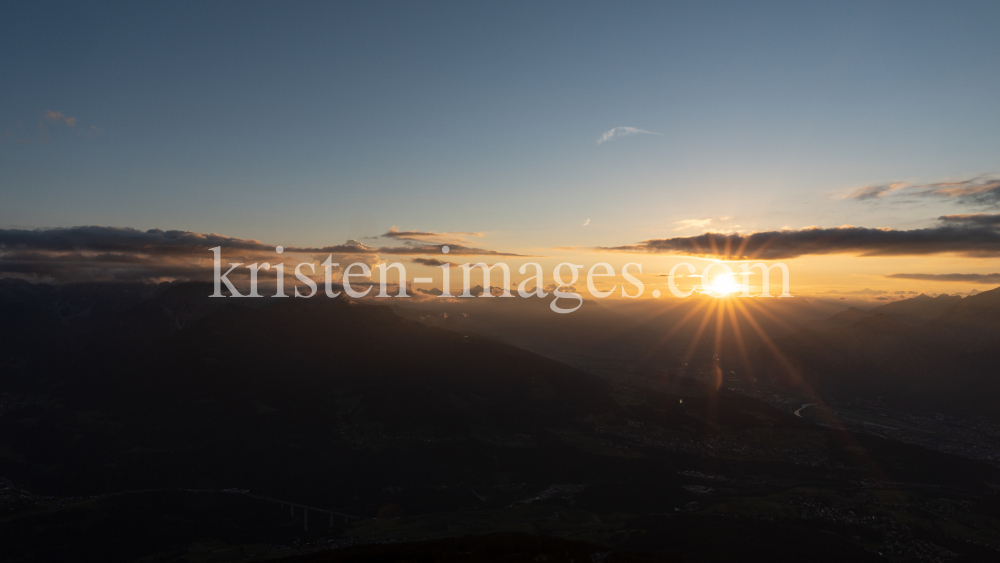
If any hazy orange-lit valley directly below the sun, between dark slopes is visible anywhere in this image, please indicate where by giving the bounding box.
[395,296,844,380]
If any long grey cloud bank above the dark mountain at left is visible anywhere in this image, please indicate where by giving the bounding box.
[0,226,519,282]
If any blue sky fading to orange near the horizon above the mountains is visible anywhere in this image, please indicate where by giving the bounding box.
[0,1,1000,292]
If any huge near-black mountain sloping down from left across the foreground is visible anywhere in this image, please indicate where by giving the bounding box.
[0,284,1000,562]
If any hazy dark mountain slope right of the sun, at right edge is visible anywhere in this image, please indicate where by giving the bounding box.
[760,288,1000,413]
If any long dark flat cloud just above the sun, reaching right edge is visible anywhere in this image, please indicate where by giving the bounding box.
[595,217,1000,260]
